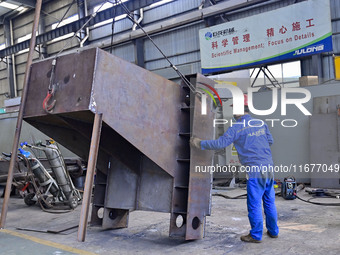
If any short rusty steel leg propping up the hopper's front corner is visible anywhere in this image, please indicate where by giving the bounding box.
[78,113,102,242]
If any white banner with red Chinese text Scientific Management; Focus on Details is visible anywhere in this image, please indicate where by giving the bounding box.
[199,0,332,74]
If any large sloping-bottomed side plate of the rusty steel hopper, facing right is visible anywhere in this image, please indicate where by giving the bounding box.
[90,51,180,176]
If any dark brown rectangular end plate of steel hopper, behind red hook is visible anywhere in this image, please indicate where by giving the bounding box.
[24,49,96,118]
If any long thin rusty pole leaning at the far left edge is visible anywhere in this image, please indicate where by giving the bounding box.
[0,0,42,228]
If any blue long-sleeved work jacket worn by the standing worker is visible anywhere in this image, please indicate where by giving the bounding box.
[201,114,273,166]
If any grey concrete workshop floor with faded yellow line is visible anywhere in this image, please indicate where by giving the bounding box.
[0,190,340,255]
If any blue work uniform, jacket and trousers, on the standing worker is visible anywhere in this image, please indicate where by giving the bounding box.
[201,114,279,240]
